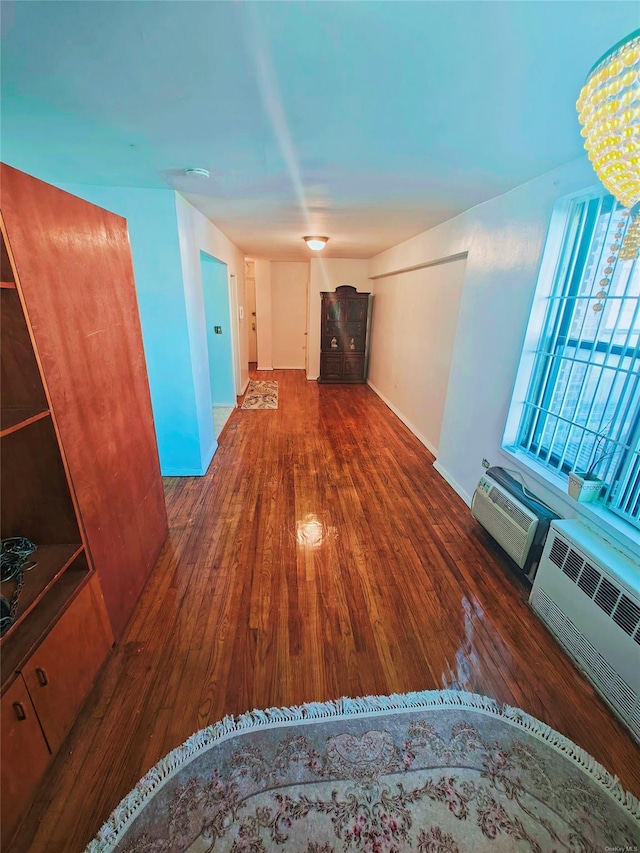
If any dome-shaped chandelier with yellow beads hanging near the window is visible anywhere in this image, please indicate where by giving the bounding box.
[576,30,640,261]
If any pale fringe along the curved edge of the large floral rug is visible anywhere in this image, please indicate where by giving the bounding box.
[85,690,640,853]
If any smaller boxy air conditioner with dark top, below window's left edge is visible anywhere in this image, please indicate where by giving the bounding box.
[471,475,539,569]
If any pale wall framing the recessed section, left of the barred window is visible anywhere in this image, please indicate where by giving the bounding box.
[369,157,596,515]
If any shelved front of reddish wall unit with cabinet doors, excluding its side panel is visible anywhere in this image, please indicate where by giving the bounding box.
[0,215,111,847]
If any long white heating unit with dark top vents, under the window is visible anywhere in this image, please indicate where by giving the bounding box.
[529,521,640,741]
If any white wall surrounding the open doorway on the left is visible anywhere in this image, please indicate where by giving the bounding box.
[176,193,249,466]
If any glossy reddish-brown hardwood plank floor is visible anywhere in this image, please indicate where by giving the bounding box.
[11,371,640,853]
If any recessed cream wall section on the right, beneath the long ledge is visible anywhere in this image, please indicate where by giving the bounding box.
[368,260,465,455]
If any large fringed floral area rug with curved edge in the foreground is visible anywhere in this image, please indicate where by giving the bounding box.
[87,691,640,853]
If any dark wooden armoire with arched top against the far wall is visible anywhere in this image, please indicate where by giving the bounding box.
[318,284,371,383]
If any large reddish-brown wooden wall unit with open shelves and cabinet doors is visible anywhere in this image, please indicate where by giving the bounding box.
[0,164,167,844]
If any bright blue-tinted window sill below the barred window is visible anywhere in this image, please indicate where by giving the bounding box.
[500,447,640,564]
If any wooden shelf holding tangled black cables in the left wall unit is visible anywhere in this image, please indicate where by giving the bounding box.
[0,545,91,680]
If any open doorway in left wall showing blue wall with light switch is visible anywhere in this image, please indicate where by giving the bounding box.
[200,252,236,438]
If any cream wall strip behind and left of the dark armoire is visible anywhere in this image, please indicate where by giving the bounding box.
[307,258,371,379]
